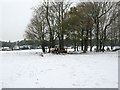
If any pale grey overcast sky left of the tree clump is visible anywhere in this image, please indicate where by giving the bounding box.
[0,0,40,41]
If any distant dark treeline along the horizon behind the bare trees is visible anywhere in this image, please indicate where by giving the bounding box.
[0,39,119,48]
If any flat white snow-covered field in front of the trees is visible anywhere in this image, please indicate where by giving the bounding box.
[0,50,118,88]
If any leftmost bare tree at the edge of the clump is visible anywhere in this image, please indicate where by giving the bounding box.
[25,7,47,52]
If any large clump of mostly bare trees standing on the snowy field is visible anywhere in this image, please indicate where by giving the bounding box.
[25,1,120,52]
